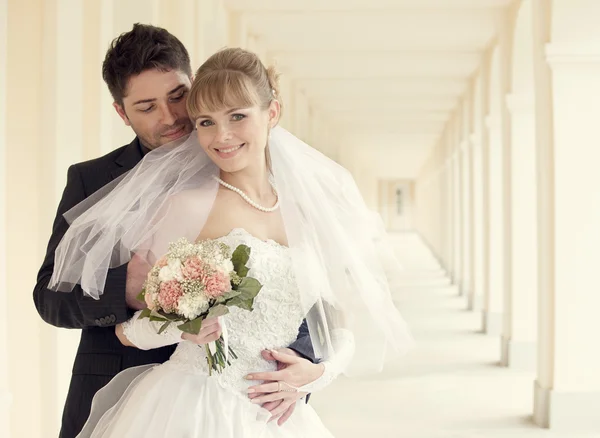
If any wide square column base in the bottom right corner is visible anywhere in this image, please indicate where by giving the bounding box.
[533,381,600,433]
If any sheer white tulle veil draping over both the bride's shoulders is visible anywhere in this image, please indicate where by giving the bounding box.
[50,127,412,375]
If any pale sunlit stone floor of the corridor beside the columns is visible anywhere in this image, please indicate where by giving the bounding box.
[311,234,600,438]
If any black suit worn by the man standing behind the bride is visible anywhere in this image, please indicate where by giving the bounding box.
[33,138,314,438]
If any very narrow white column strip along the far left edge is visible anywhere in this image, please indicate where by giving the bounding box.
[0,0,12,437]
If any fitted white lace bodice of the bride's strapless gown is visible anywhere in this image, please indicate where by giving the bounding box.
[164,229,304,391]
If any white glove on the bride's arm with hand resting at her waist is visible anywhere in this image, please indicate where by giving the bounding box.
[298,329,355,392]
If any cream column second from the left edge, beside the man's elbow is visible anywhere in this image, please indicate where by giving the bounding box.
[2,0,44,438]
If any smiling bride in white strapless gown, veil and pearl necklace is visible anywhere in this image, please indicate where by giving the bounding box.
[51,49,411,438]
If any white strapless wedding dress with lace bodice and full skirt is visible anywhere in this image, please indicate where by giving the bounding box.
[78,229,333,438]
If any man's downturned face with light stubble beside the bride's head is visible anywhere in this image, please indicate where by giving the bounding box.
[114,69,193,149]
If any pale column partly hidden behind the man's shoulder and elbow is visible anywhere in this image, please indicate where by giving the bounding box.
[39,0,87,433]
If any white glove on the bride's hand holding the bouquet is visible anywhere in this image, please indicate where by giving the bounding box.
[122,310,183,350]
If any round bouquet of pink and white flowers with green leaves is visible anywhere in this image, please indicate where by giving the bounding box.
[138,238,262,374]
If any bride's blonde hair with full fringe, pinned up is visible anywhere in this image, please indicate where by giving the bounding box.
[187,48,281,120]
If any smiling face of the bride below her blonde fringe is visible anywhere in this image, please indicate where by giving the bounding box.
[196,101,279,173]
